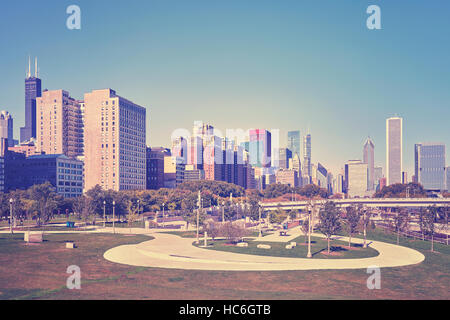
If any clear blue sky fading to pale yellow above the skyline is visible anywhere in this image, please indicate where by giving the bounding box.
[0,0,450,178]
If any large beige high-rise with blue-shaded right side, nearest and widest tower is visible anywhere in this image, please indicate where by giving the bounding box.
[84,89,146,191]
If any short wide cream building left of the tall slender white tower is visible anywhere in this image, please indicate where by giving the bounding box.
[345,160,367,198]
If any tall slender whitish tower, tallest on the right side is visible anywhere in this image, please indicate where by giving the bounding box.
[386,117,403,186]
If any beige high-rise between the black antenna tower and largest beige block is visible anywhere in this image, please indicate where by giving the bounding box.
[36,90,84,158]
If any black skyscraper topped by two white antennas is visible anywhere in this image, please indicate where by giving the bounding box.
[20,58,42,142]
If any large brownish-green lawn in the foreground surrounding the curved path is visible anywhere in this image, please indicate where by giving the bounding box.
[0,230,450,300]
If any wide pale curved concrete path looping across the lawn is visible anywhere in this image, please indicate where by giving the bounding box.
[104,233,425,271]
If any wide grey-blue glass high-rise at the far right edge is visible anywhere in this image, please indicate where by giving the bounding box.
[414,143,446,191]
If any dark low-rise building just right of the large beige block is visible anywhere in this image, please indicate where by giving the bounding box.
[147,147,170,190]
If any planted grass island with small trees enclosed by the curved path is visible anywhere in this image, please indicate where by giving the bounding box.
[194,237,378,259]
